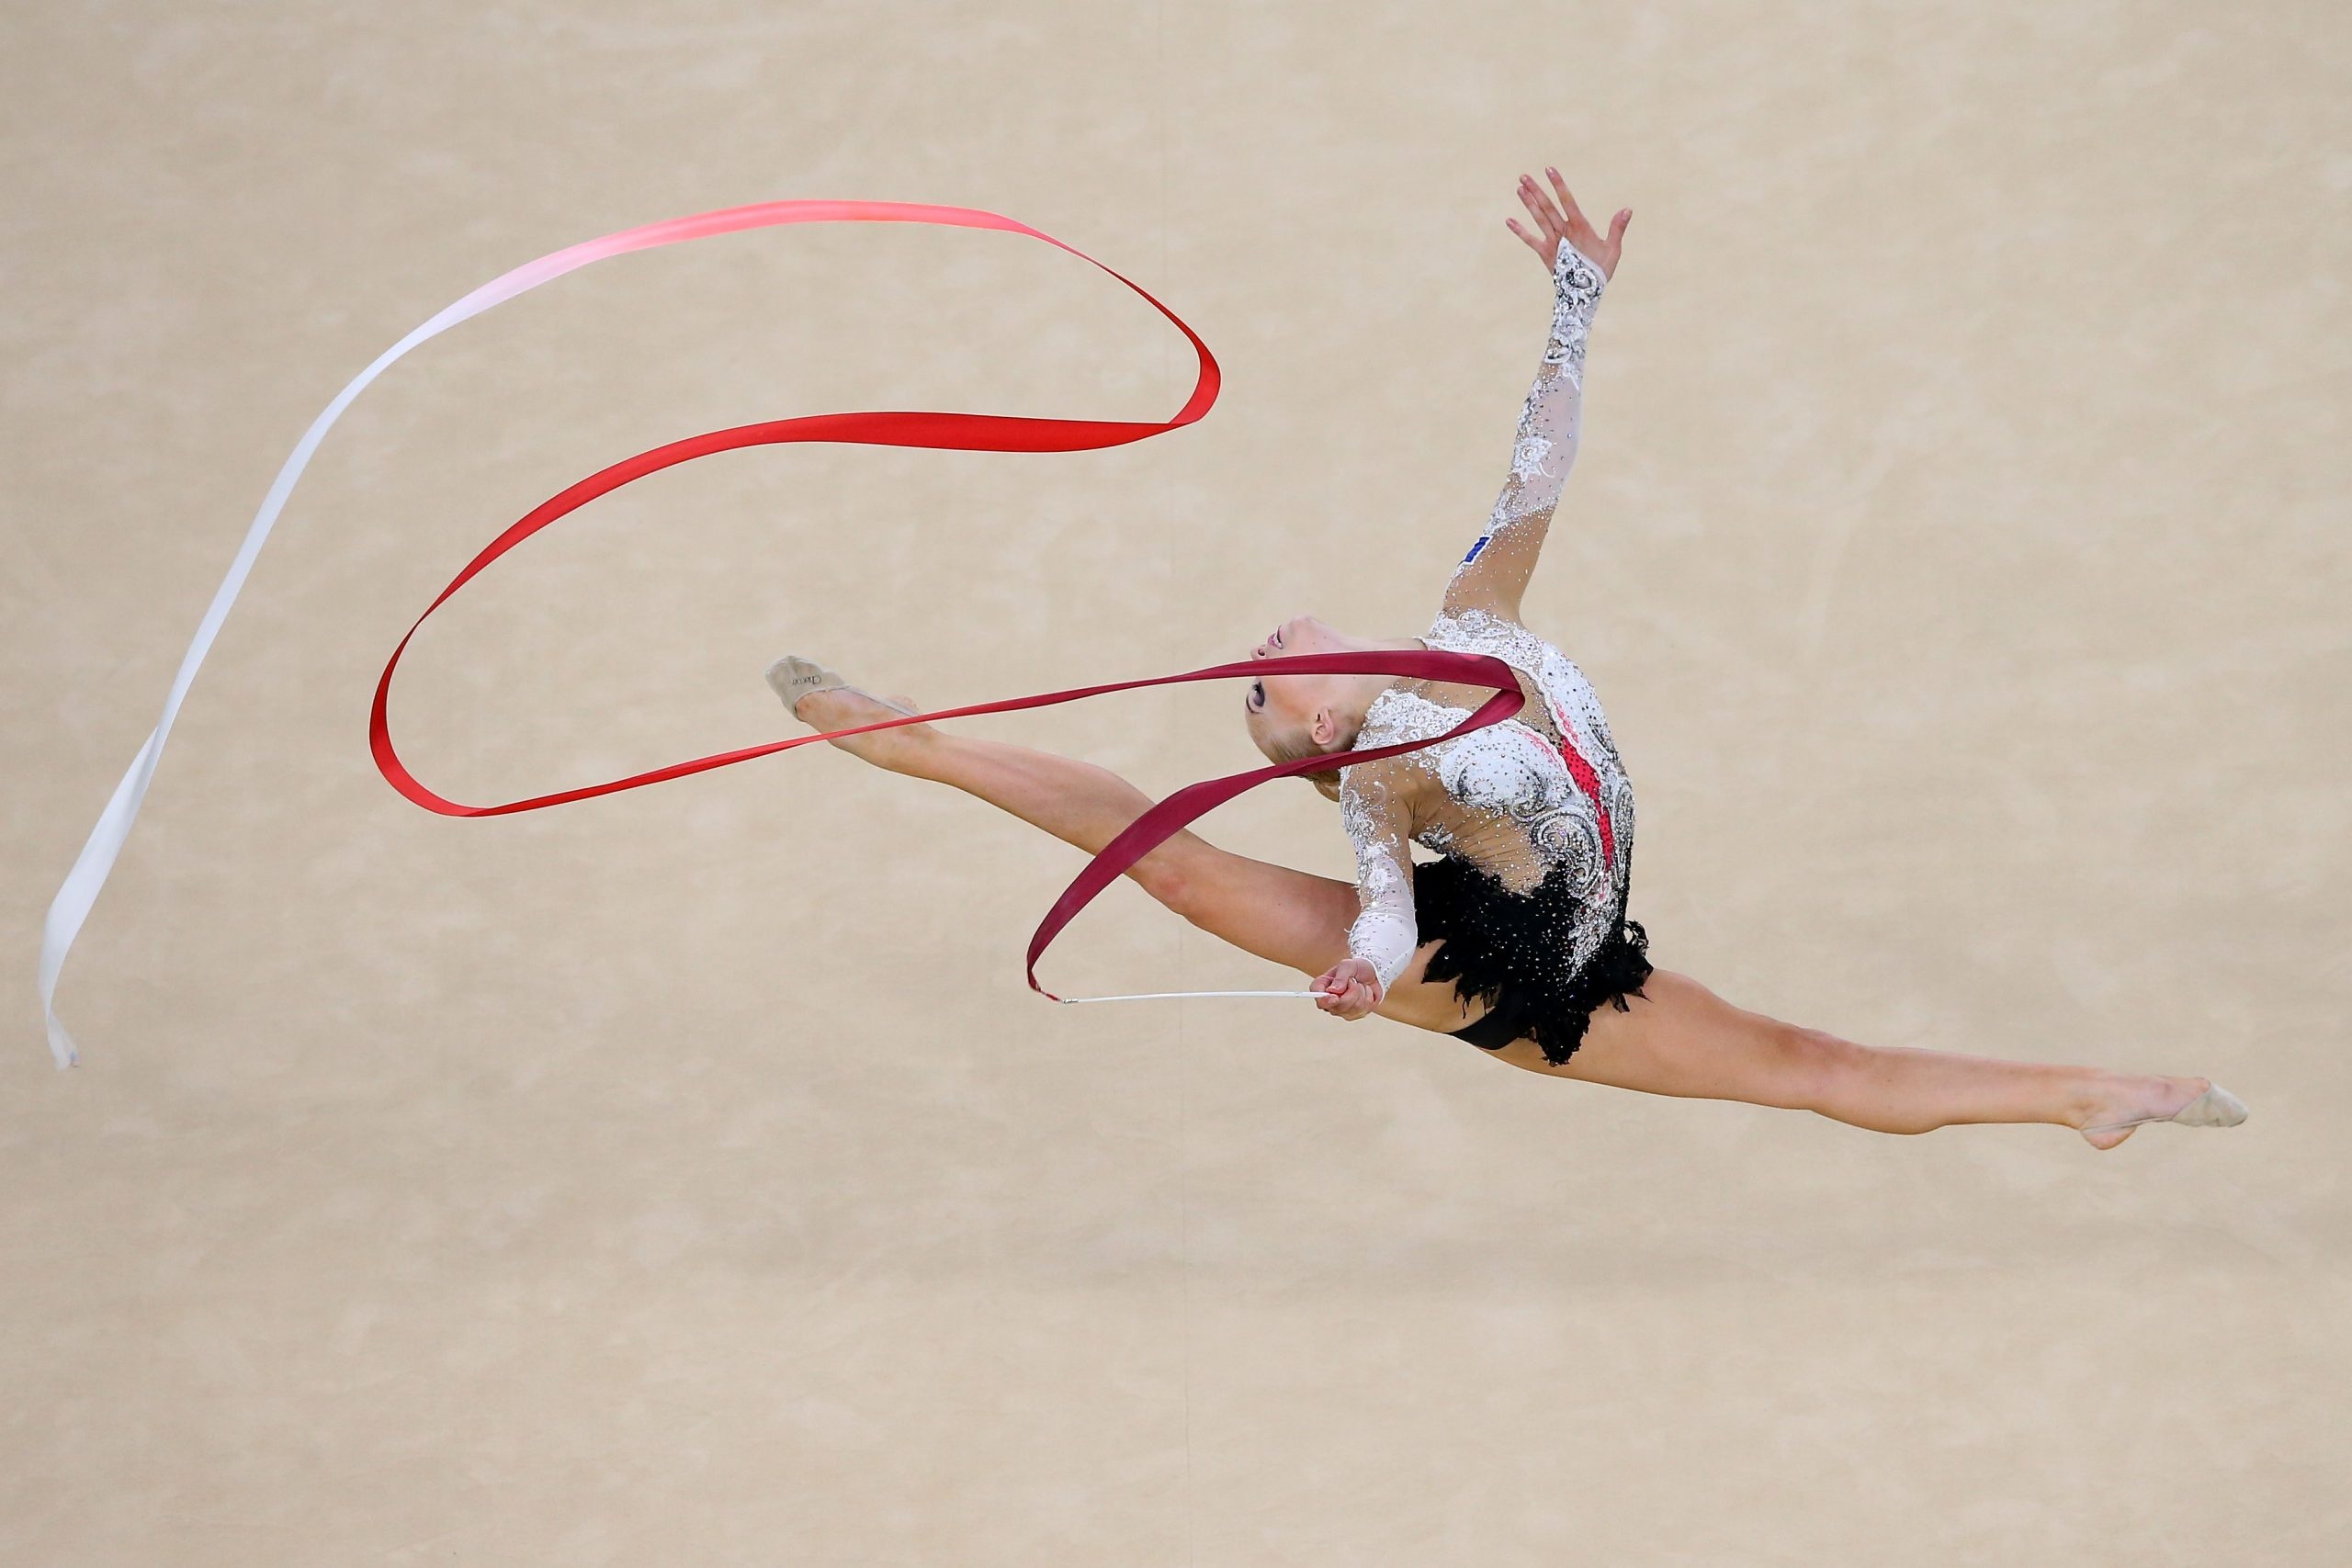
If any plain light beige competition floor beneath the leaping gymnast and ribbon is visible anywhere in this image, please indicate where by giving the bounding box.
[0,0,2352,1568]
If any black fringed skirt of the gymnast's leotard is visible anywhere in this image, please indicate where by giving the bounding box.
[1414,856,1651,1065]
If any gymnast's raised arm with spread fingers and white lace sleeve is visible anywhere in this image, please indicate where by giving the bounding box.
[1444,169,1633,621]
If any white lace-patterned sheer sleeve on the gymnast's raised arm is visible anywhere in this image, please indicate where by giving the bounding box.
[1446,240,1609,609]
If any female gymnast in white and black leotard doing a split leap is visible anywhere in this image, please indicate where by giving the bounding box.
[767,169,2246,1149]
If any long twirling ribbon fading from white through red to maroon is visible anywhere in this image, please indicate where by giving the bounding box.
[40,200,1526,1067]
